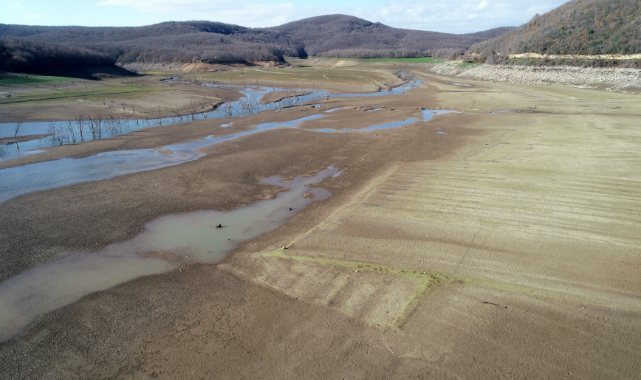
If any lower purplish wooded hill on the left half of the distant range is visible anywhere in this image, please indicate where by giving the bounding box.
[0,21,297,63]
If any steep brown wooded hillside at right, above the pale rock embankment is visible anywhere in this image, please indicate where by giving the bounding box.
[471,0,641,55]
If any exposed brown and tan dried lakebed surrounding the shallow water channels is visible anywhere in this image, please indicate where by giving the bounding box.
[0,66,641,379]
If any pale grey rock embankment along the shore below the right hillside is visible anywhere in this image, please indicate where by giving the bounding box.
[432,62,641,91]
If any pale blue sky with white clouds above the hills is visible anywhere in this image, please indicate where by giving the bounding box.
[0,0,567,33]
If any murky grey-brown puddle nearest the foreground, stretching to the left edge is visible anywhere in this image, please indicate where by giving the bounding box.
[0,166,342,341]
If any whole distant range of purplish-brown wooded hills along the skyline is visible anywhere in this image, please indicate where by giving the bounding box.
[0,15,510,67]
